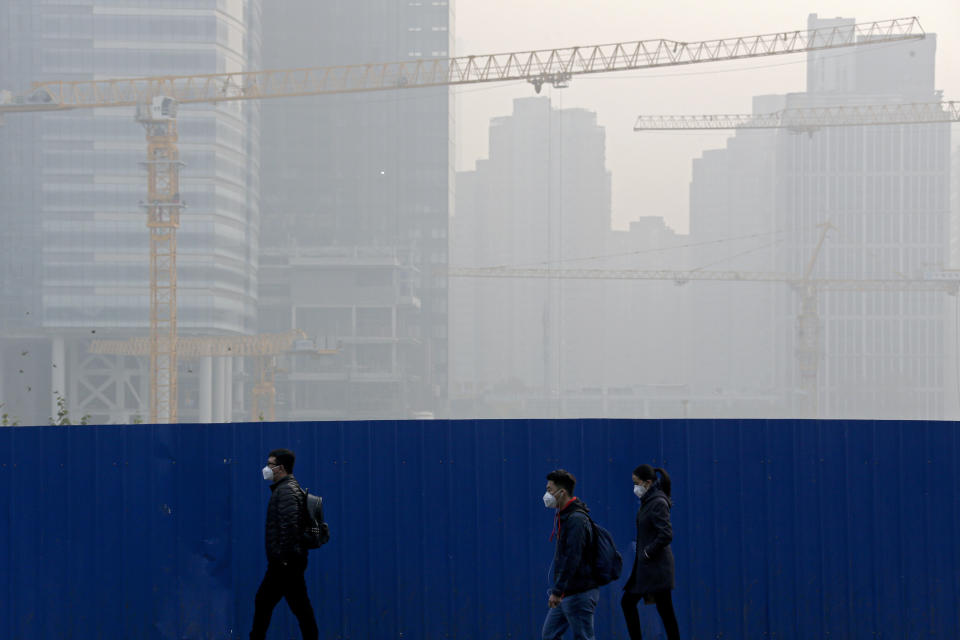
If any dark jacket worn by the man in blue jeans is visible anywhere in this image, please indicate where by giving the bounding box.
[550,498,597,596]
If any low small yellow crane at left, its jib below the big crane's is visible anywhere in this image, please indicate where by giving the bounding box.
[90,329,338,421]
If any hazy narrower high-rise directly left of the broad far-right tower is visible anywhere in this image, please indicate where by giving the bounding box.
[684,96,784,404]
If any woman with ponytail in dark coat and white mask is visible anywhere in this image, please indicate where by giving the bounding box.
[620,464,680,640]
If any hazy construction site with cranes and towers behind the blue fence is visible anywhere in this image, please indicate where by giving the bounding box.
[0,6,960,425]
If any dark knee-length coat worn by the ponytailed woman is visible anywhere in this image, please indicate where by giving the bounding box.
[623,485,674,595]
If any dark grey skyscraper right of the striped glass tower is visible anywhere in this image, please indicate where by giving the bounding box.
[259,0,454,419]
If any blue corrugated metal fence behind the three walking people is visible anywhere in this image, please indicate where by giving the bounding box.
[0,420,960,640]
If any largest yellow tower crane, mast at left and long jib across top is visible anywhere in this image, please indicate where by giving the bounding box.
[0,17,924,423]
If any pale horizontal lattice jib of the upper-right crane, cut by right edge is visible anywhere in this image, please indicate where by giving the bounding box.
[633,102,960,131]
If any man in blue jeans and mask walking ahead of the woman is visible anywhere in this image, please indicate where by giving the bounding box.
[541,469,600,640]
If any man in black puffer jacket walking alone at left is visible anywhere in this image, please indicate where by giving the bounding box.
[250,449,320,640]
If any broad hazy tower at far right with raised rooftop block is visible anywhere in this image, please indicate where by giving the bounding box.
[691,15,953,419]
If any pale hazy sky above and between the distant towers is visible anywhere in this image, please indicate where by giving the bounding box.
[454,0,960,232]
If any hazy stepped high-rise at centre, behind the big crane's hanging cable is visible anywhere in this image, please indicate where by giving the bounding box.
[452,97,611,416]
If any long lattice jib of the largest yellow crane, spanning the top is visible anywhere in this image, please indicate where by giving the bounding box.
[0,17,924,114]
